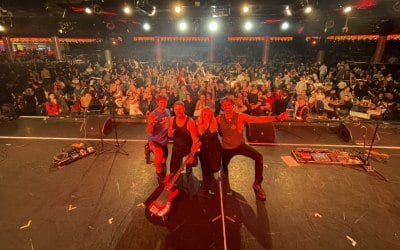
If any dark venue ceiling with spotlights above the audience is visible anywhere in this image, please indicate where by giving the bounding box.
[0,0,400,37]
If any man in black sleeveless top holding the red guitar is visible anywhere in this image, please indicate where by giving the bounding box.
[168,101,199,177]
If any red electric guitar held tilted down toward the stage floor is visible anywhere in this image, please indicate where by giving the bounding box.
[148,145,200,217]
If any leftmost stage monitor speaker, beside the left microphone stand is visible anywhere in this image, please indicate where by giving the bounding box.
[81,115,112,137]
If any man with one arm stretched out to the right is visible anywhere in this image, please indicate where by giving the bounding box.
[217,98,287,201]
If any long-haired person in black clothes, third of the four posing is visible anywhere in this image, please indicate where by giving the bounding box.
[196,107,222,194]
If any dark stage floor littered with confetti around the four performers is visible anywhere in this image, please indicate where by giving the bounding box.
[0,118,400,250]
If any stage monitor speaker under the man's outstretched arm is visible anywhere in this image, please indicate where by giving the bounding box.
[246,122,275,142]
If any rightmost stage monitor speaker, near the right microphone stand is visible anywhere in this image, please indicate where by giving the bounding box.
[338,123,380,145]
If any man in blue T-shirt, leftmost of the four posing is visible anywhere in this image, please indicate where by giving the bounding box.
[146,95,170,182]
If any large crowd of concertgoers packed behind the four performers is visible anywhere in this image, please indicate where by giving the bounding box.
[0,47,400,120]
